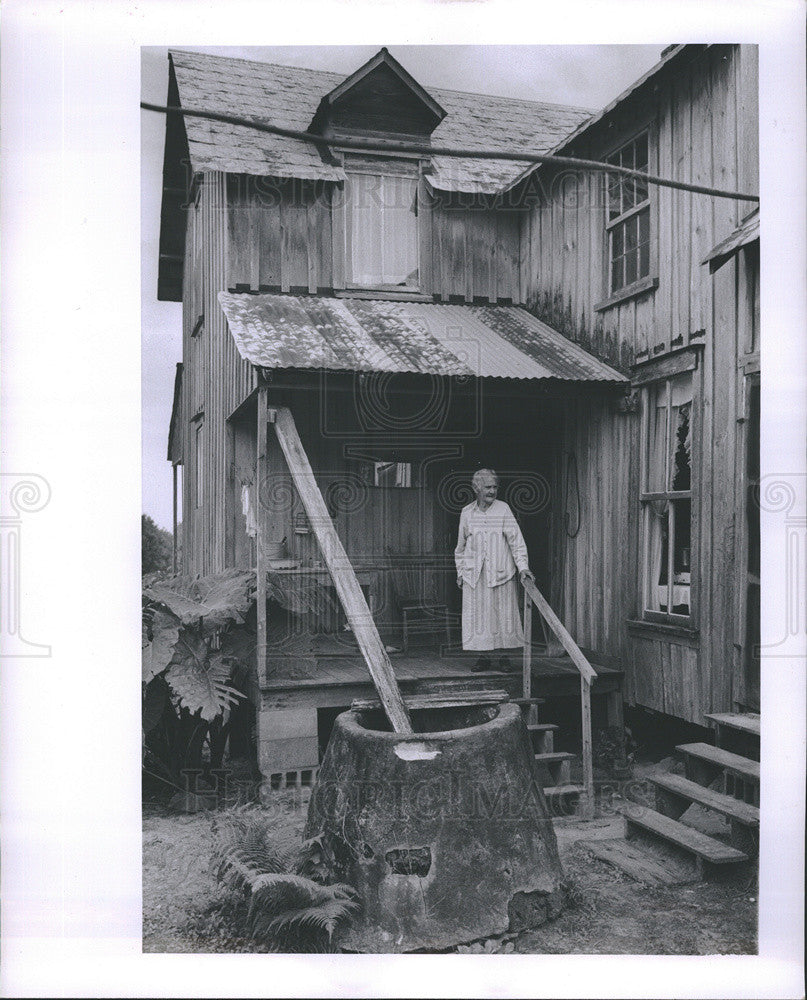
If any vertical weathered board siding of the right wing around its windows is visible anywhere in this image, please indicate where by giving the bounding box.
[521,46,758,724]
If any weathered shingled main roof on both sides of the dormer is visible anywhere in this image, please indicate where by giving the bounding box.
[170,50,591,194]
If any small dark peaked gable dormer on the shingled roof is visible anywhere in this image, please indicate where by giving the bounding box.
[309,48,446,141]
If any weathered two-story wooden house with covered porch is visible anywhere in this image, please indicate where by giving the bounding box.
[159,45,759,774]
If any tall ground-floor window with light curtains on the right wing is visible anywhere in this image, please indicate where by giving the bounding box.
[641,372,693,621]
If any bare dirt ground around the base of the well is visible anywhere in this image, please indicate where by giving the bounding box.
[143,792,757,955]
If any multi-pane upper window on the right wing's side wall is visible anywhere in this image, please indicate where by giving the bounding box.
[606,132,650,295]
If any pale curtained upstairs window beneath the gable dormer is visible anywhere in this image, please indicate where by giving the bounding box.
[345,171,418,289]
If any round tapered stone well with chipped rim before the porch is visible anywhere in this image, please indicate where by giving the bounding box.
[306,704,563,952]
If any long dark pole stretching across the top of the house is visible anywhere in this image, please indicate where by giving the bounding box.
[140,101,759,202]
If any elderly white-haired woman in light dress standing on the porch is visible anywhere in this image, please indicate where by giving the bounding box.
[454,469,535,671]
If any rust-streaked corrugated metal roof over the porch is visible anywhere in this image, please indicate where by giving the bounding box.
[219,292,627,383]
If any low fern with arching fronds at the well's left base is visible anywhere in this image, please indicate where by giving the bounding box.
[214,807,359,952]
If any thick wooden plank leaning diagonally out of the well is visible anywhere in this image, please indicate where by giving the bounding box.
[272,406,412,733]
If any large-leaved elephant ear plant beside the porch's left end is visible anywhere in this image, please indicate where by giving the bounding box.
[142,570,255,793]
